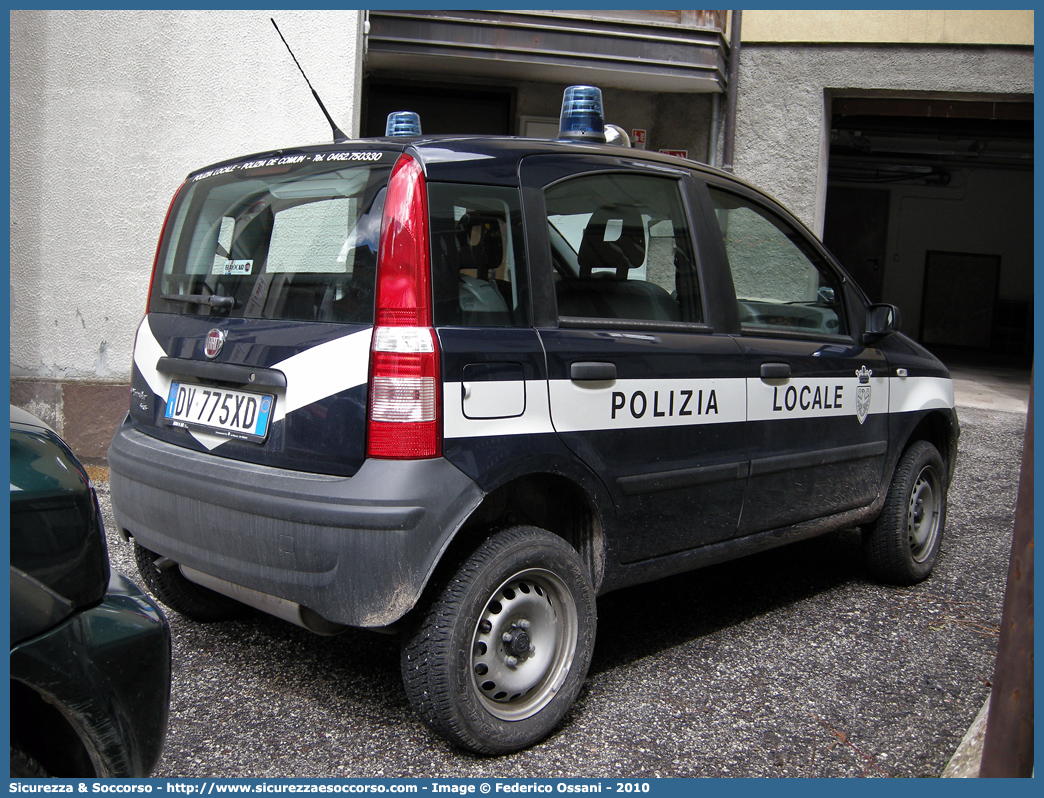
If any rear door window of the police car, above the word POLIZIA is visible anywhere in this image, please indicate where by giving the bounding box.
[544,174,702,322]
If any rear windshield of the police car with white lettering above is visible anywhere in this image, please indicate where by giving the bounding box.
[149,159,394,324]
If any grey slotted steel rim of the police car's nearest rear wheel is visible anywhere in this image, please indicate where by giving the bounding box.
[469,568,578,721]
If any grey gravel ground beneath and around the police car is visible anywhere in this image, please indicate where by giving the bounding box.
[98,408,1025,778]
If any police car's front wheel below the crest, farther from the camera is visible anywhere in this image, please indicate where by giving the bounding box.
[863,441,947,585]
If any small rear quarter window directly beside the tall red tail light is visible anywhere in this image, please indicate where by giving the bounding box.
[428,183,529,327]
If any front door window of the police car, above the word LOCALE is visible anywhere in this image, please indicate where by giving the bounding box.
[709,186,848,335]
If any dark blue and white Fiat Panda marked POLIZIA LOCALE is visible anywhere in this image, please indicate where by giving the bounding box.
[109,85,958,753]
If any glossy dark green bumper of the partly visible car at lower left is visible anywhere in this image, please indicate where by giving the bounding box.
[10,572,170,778]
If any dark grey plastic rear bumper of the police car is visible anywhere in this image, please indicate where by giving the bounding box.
[109,423,482,627]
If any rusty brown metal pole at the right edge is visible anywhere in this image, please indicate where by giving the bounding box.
[979,380,1034,778]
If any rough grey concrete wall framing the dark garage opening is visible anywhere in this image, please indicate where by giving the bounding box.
[735,45,1034,235]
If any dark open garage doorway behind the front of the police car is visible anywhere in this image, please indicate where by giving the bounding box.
[824,97,1034,361]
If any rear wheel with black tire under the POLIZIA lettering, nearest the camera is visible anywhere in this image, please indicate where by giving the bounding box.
[401,526,596,754]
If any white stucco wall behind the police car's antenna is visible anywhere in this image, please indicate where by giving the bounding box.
[10,10,362,381]
